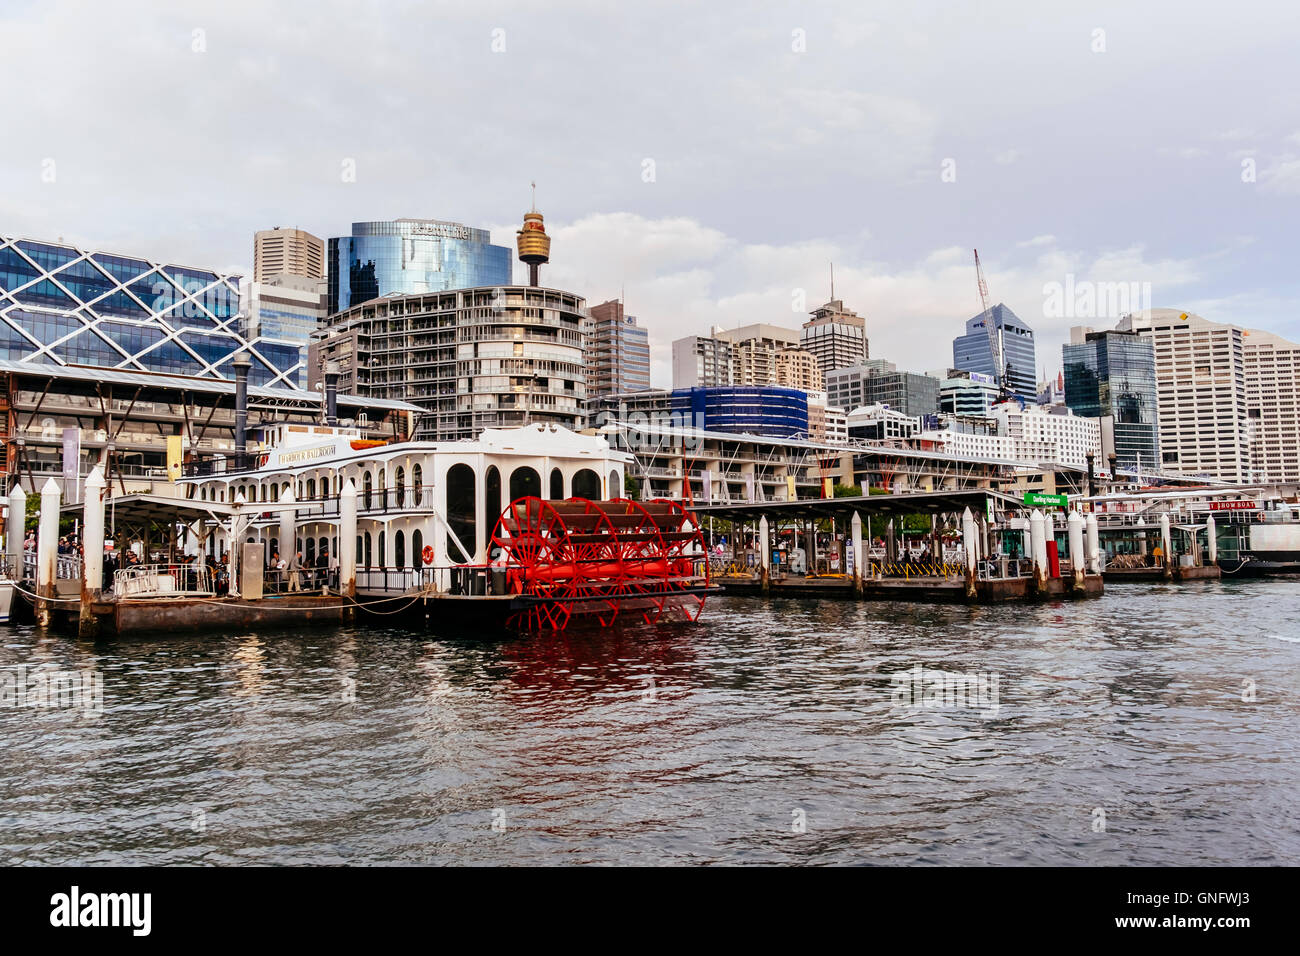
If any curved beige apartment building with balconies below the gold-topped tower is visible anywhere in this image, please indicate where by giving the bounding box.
[309,285,589,441]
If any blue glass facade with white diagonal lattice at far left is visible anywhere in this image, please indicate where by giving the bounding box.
[0,238,303,388]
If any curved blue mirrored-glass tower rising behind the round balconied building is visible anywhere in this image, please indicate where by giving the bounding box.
[326,219,511,315]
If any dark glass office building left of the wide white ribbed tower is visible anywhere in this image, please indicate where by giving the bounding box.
[1061,332,1160,468]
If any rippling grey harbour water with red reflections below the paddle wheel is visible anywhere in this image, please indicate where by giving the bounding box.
[0,579,1300,865]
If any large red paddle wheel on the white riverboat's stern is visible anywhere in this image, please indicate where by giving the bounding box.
[491,498,710,631]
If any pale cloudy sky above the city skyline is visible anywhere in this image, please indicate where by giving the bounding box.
[0,0,1300,385]
